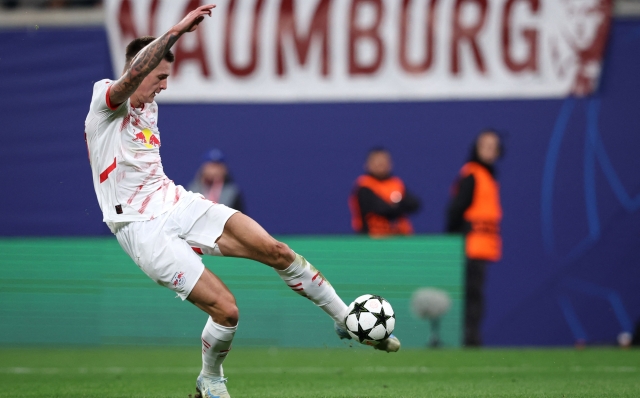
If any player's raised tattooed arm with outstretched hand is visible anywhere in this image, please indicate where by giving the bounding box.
[109,4,215,107]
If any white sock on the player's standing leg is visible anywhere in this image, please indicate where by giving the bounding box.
[201,317,238,377]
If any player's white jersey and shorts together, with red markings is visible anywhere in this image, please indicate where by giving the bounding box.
[85,80,236,300]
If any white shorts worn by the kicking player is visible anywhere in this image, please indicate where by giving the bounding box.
[115,192,237,300]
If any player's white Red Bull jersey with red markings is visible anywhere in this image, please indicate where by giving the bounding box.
[85,79,185,231]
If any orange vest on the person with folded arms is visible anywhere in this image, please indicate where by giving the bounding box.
[349,175,413,236]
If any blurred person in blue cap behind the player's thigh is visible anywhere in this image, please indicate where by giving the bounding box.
[188,148,245,213]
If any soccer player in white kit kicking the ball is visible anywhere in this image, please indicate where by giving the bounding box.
[85,5,400,397]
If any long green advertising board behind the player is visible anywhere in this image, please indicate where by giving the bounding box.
[0,236,464,347]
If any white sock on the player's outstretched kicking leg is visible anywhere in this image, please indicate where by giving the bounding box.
[276,254,347,327]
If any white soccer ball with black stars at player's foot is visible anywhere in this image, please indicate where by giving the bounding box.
[344,294,396,345]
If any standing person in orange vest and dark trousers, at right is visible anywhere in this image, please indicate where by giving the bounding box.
[447,130,503,347]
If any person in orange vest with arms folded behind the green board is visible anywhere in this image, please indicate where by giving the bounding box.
[349,148,420,236]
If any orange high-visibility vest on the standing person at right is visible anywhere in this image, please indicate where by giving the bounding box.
[460,162,502,261]
